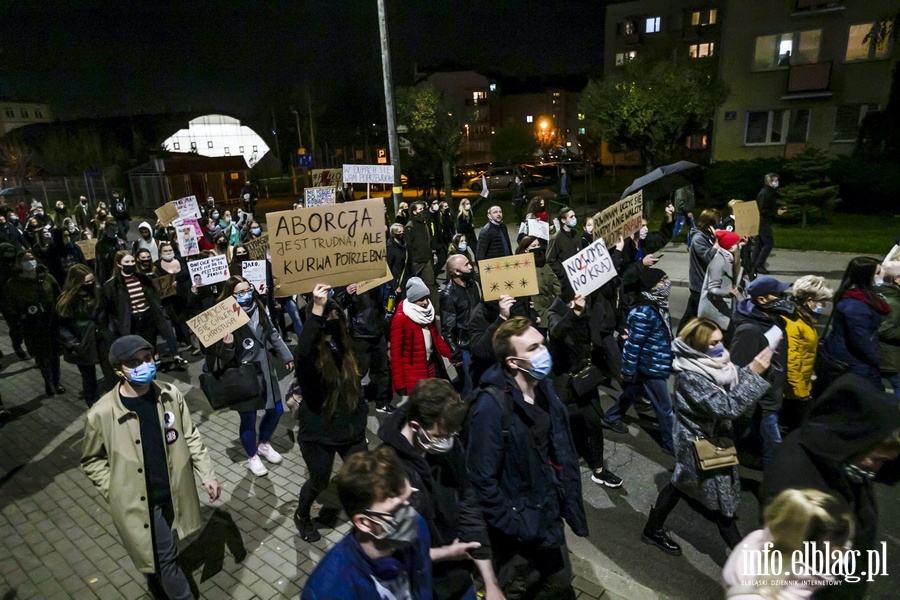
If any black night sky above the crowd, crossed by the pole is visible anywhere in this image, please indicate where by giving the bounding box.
[0,0,609,123]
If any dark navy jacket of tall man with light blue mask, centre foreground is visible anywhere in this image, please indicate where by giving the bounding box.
[466,365,588,548]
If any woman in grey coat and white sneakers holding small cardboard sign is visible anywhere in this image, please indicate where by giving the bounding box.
[206,277,294,477]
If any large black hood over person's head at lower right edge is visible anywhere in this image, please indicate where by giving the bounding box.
[800,373,900,462]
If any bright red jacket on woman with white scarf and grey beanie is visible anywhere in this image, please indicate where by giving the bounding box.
[391,300,453,394]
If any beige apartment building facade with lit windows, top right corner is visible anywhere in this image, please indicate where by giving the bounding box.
[712,0,898,160]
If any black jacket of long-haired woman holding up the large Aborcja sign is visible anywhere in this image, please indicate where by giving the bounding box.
[294,313,368,444]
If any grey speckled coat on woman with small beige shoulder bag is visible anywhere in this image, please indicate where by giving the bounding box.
[672,366,769,517]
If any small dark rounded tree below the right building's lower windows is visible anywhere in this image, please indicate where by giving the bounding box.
[778,148,838,229]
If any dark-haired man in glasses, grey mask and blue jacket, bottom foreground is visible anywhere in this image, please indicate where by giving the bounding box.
[300,446,434,600]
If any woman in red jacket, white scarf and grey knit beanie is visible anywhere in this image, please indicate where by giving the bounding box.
[390,277,453,396]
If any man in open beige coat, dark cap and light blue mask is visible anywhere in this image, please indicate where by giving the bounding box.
[81,335,221,600]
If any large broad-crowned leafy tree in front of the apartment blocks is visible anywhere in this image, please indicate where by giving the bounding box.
[581,60,728,171]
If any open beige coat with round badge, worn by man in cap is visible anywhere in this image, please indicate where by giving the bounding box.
[81,382,215,573]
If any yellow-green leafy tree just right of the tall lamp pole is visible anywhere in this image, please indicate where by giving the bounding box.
[394,86,465,199]
